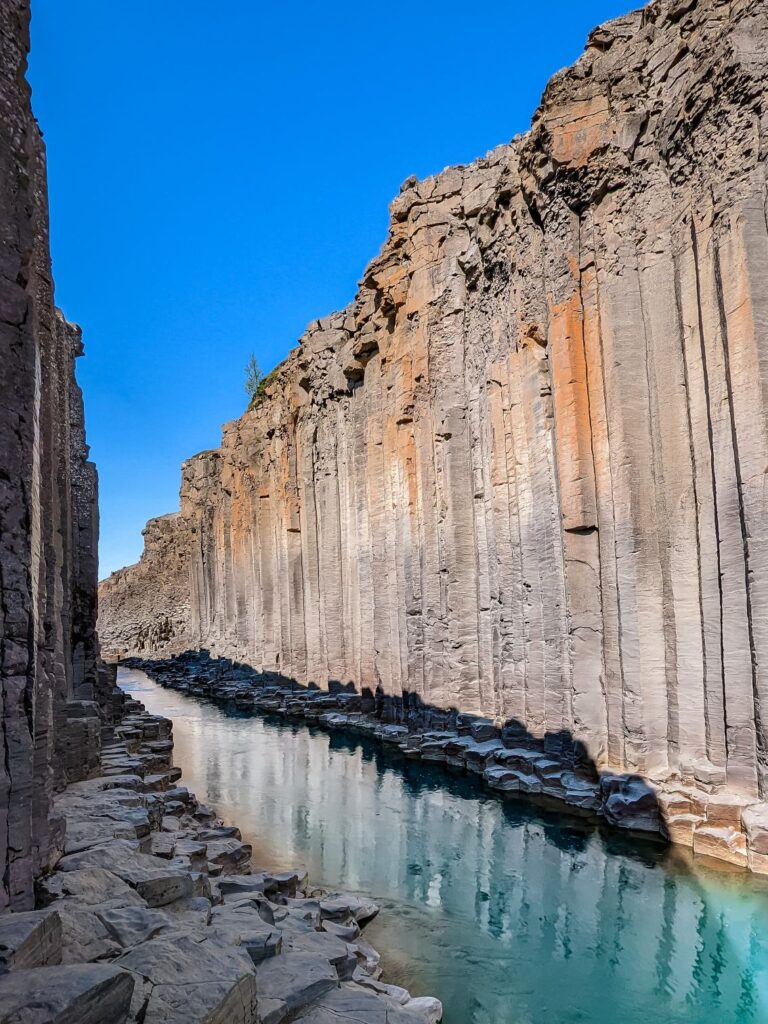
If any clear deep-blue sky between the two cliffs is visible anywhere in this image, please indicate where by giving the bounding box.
[30,0,638,577]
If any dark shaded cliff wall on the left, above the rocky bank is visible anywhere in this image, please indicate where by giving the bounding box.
[0,0,104,911]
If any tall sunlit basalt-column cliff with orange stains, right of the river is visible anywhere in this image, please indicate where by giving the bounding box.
[99,0,768,796]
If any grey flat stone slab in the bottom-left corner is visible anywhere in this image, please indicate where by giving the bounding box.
[0,964,134,1024]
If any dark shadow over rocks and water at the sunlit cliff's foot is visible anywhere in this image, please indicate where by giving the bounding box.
[121,649,679,863]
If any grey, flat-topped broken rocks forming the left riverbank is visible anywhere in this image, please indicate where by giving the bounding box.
[0,689,441,1024]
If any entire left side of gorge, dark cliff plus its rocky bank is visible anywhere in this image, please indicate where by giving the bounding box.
[0,0,442,1024]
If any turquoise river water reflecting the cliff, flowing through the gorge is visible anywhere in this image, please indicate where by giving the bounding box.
[120,670,768,1024]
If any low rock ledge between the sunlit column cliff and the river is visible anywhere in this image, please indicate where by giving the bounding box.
[123,651,768,873]
